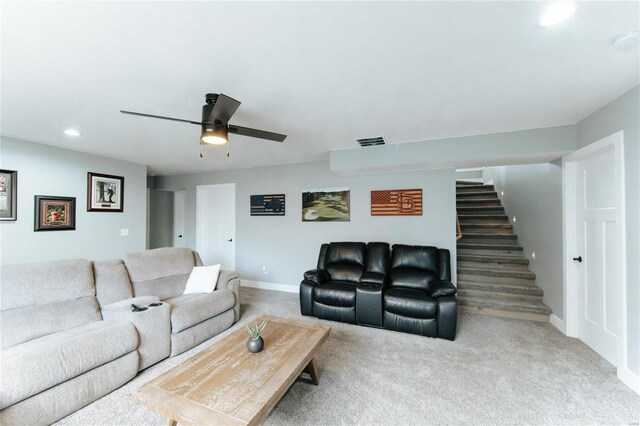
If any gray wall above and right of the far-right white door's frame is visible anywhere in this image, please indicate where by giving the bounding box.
[577,86,640,374]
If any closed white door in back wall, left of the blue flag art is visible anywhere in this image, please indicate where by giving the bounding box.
[196,183,236,270]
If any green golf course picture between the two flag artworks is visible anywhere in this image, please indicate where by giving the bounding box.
[302,186,350,222]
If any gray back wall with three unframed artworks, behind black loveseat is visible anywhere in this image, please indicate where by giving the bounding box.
[156,161,456,288]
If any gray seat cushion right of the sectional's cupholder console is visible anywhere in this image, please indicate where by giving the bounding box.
[163,289,236,334]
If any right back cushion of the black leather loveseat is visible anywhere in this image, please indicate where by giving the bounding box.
[390,244,440,290]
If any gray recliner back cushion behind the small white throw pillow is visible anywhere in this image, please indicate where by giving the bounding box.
[124,247,196,300]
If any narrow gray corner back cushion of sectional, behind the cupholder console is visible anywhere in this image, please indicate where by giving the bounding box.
[93,259,133,307]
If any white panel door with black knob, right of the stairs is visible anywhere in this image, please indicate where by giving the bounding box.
[574,147,620,365]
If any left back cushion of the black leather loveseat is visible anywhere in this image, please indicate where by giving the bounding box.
[325,242,366,283]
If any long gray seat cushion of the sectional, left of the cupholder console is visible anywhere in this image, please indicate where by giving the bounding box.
[0,321,138,409]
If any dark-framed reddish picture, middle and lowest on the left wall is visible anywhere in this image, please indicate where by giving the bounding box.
[33,195,76,231]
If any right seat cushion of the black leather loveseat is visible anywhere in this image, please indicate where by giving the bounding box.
[384,287,438,319]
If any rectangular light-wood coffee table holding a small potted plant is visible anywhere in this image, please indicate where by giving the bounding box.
[131,316,331,425]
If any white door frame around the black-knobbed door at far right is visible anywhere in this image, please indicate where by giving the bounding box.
[562,130,634,380]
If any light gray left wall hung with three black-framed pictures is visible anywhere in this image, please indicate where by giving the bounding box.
[0,137,147,264]
